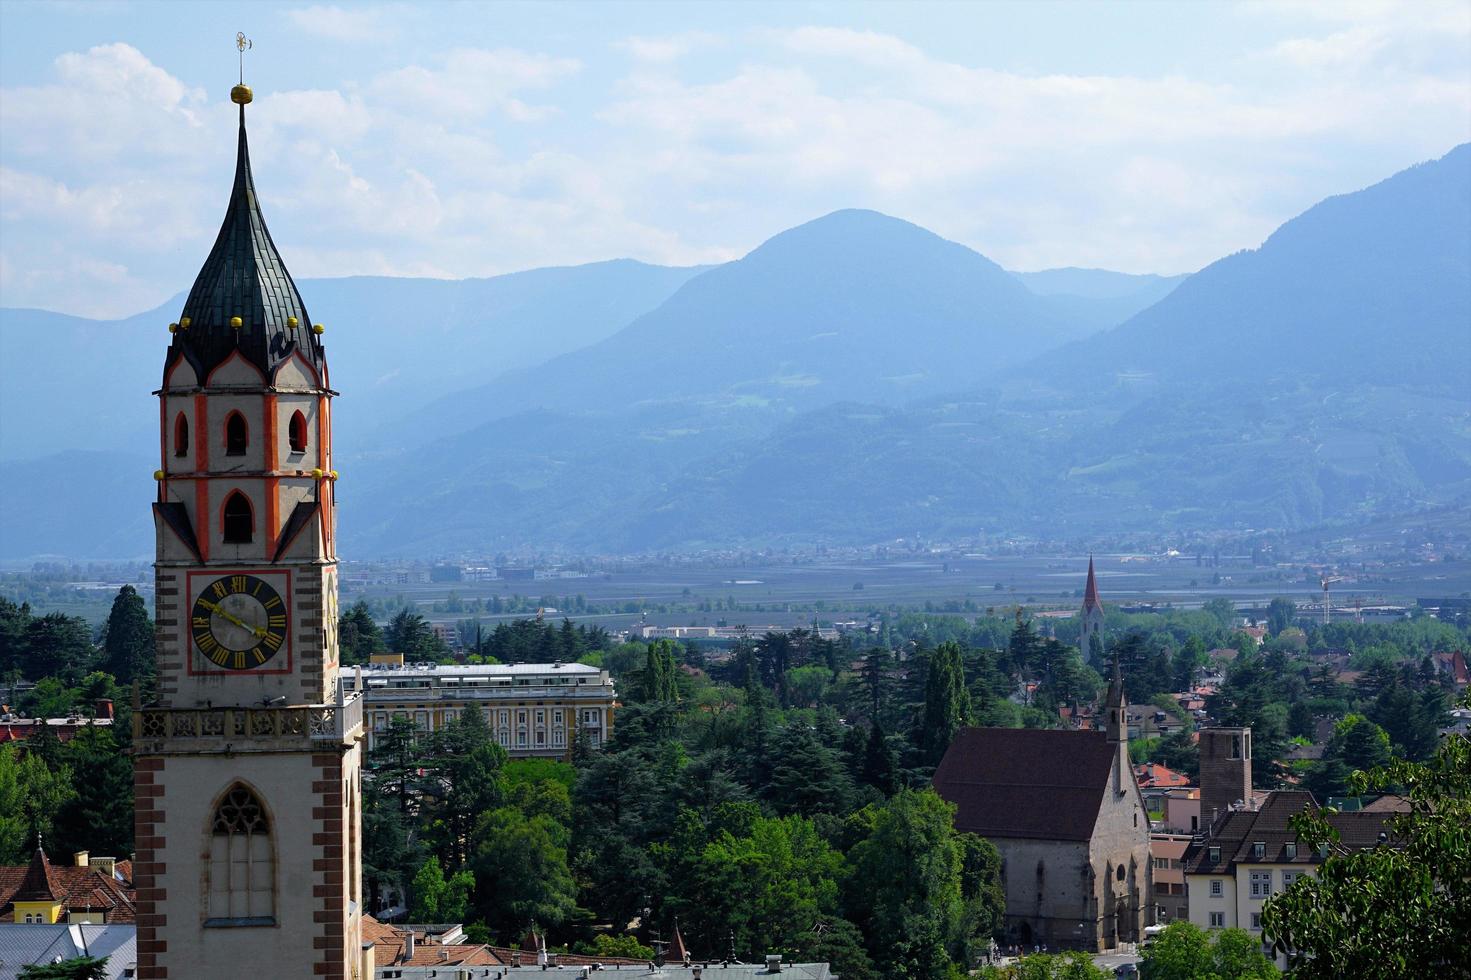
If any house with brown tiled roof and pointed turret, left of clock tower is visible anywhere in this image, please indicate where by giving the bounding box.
[0,846,137,926]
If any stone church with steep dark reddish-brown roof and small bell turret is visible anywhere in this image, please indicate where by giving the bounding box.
[934,662,1152,951]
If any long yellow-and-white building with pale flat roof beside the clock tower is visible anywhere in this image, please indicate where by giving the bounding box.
[344,664,615,758]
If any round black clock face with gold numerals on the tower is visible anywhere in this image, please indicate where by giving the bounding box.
[190,572,288,671]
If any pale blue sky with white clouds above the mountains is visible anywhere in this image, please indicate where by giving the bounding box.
[0,0,1471,316]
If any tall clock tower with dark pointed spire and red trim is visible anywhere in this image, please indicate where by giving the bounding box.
[134,78,363,980]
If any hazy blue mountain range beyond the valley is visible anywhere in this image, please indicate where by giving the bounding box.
[0,146,1471,558]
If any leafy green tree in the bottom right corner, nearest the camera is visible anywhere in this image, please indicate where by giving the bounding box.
[1262,697,1471,980]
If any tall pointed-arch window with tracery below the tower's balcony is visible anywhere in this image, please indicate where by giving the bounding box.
[206,783,275,926]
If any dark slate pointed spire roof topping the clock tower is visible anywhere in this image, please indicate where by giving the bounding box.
[169,104,325,381]
